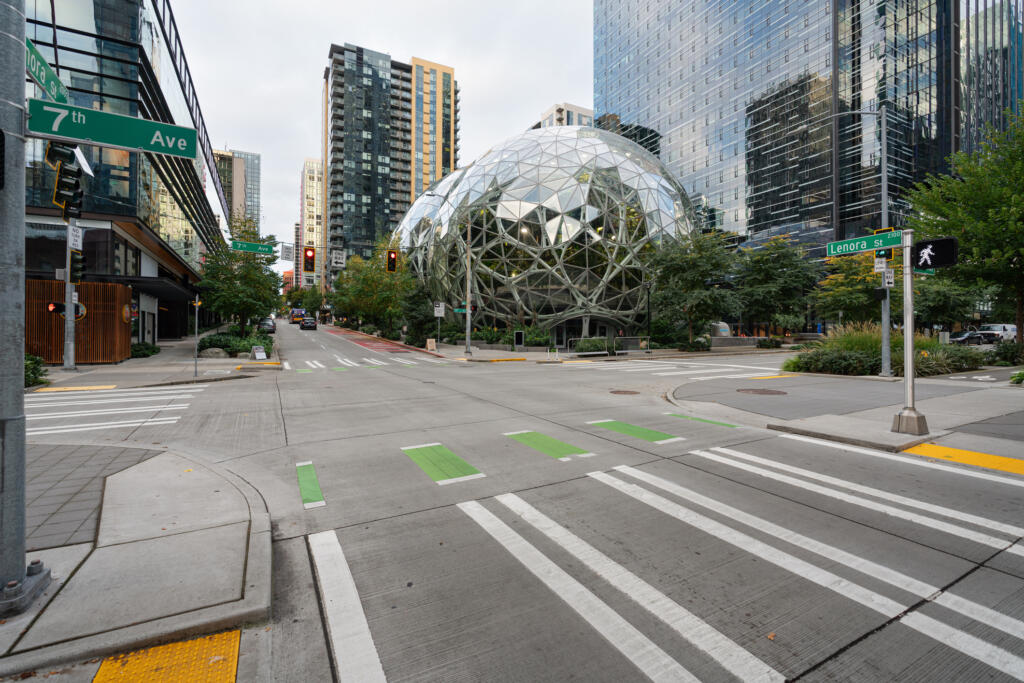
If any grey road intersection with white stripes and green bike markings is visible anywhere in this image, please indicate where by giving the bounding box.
[39,324,1024,681]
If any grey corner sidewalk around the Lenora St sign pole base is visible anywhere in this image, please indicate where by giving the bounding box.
[670,374,1024,458]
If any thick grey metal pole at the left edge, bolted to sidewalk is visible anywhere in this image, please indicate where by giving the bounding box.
[0,0,50,614]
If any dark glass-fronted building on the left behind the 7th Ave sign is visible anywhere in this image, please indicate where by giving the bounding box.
[26,0,228,362]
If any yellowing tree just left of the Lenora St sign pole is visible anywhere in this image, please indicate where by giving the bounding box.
[812,252,903,323]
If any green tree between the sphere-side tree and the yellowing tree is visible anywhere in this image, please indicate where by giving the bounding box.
[736,236,821,329]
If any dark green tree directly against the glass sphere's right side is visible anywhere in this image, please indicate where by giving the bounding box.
[651,232,740,343]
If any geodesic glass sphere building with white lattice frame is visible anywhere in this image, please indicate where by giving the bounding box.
[397,126,695,327]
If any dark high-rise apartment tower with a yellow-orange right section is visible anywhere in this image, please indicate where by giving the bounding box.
[324,43,459,282]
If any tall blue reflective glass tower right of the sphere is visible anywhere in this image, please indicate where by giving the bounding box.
[594,0,1024,246]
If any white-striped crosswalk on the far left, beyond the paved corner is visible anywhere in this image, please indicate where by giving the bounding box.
[25,384,206,437]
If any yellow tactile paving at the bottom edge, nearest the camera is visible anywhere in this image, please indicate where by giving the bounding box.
[92,631,241,683]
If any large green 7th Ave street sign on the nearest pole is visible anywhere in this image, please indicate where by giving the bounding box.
[28,98,197,159]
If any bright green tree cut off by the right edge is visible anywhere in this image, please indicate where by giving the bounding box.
[907,105,1024,342]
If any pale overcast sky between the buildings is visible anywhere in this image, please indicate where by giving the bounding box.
[172,0,593,269]
